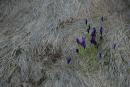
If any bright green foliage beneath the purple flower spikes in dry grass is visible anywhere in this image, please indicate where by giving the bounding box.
[77,33,98,70]
